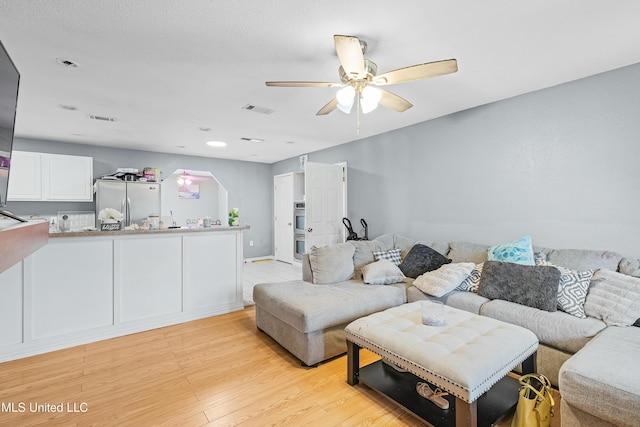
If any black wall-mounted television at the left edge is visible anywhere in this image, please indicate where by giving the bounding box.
[0,41,20,219]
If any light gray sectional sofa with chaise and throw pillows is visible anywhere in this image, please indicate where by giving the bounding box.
[254,234,640,426]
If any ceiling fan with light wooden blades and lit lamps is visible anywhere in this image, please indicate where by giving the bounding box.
[266,35,458,121]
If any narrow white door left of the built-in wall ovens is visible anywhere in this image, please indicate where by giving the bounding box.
[273,173,293,264]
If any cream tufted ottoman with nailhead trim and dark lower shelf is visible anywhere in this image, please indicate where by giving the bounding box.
[345,302,538,426]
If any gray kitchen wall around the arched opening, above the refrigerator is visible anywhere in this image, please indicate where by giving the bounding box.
[7,138,273,258]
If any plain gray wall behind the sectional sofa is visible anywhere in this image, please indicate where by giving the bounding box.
[273,64,640,256]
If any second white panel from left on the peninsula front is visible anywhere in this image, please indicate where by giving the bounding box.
[30,238,113,340]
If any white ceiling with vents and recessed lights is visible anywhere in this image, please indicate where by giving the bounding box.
[0,0,640,163]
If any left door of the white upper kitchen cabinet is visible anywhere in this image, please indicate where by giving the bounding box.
[7,151,42,202]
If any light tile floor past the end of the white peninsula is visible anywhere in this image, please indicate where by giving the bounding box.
[242,259,302,306]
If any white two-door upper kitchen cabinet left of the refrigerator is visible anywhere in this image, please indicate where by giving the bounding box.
[8,151,93,202]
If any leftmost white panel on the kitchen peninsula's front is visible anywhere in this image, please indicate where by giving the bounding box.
[0,262,23,348]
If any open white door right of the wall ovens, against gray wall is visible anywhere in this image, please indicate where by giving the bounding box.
[304,162,346,252]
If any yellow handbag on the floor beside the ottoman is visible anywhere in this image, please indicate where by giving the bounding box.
[511,374,555,427]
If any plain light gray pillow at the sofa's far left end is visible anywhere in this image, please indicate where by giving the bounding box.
[309,243,355,285]
